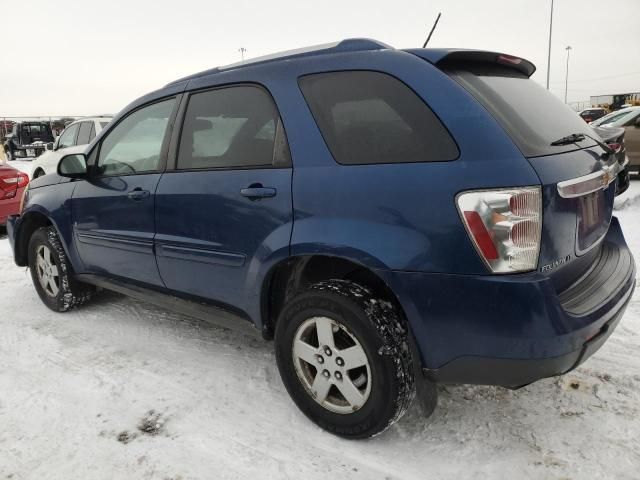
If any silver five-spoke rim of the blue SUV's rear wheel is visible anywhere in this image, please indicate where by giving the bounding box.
[292,317,372,414]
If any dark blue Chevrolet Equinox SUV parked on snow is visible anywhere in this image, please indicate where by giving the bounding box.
[8,39,635,438]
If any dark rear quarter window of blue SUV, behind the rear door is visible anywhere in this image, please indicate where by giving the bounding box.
[299,71,459,165]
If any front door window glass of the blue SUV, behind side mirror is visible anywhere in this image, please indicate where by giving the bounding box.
[98,98,175,175]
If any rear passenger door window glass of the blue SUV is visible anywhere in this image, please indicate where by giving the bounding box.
[178,86,282,169]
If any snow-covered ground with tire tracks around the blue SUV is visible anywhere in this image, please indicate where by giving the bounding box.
[0,171,640,480]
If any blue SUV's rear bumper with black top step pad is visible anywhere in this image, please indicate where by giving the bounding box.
[379,217,635,386]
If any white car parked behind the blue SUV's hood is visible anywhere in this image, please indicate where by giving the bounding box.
[31,116,112,178]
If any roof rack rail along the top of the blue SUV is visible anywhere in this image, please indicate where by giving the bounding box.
[166,38,393,87]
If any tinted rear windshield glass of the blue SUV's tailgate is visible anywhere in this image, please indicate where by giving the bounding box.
[443,62,595,157]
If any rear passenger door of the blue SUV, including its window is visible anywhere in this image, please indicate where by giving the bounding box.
[155,85,292,306]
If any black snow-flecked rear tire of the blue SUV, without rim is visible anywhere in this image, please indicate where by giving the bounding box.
[275,280,416,439]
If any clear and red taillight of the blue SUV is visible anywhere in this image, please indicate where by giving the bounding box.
[456,187,542,273]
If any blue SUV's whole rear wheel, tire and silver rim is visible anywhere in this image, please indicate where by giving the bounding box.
[275,280,415,439]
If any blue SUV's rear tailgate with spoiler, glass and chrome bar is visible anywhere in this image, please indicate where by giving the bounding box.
[411,50,618,291]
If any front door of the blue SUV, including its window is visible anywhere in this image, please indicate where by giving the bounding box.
[72,98,176,286]
